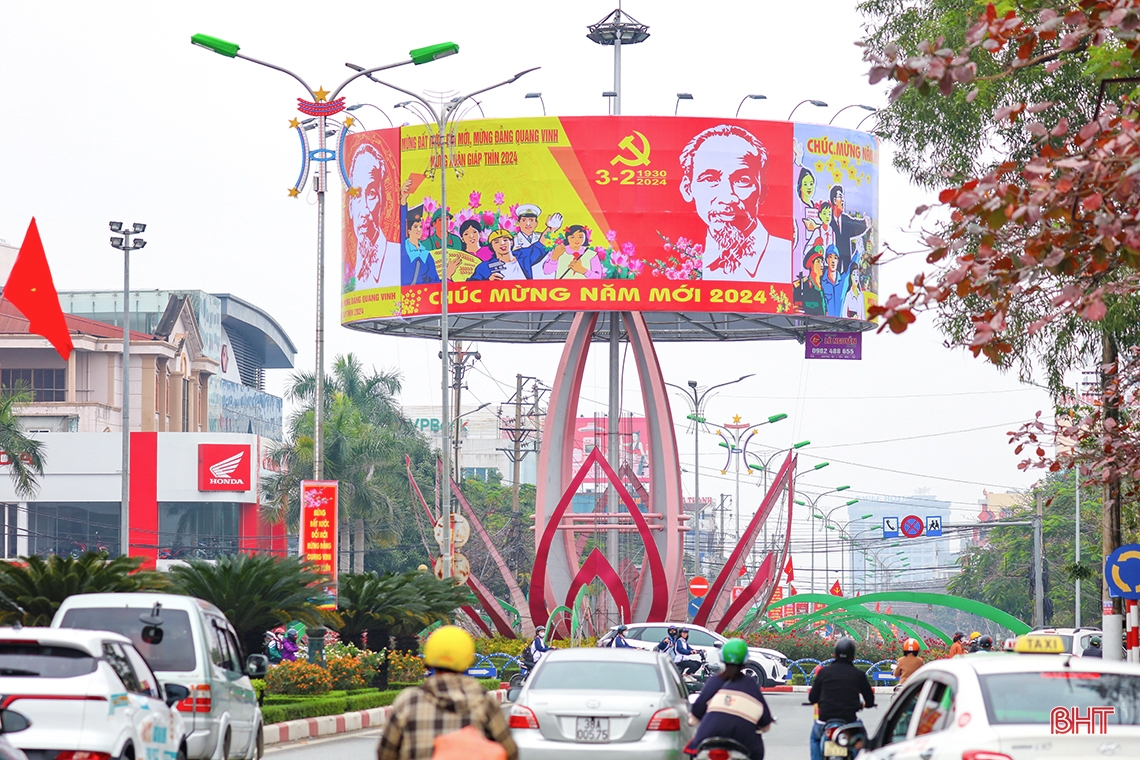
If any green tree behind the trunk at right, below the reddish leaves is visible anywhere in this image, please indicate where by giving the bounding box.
[947,472,1102,627]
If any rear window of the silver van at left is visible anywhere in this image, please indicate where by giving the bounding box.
[60,607,197,672]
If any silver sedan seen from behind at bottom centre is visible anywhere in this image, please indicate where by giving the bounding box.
[510,647,694,760]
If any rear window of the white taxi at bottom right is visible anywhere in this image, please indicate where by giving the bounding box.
[978,669,1140,726]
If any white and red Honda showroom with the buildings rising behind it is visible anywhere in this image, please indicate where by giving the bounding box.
[0,292,294,567]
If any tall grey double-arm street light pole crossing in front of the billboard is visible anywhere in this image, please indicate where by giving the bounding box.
[344,64,538,578]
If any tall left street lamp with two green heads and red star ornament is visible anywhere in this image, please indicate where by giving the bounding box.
[190,34,459,480]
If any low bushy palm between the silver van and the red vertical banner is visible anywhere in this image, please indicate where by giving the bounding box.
[170,554,326,654]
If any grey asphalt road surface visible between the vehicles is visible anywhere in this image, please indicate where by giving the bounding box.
[266,694,889,760]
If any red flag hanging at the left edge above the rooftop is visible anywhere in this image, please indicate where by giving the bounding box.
[3,216,74,360]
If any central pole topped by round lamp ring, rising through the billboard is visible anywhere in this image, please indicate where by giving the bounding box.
[586,3,649,567]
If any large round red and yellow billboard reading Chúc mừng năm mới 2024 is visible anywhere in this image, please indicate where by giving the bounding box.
[341,116,879,341]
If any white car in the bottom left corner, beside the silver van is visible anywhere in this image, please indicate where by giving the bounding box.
[0,628,189,760]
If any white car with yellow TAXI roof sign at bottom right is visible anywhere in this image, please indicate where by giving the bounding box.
[858,635,1140,760]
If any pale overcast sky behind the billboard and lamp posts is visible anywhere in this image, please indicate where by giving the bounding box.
[0,0,1049,528]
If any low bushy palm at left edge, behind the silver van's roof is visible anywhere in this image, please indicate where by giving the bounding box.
[0,551,168,626]
